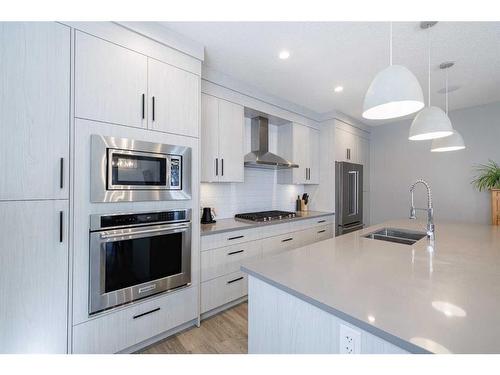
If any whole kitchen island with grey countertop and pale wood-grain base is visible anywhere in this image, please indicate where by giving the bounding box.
[242,220,500,353]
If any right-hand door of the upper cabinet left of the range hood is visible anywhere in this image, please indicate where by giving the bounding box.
[219,99,245,182]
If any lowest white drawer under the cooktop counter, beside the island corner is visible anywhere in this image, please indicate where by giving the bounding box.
[201,271,248,313]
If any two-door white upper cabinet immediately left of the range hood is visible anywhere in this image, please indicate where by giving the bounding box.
[201,94,245,182]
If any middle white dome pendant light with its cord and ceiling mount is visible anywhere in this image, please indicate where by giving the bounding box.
[408,22,453,141]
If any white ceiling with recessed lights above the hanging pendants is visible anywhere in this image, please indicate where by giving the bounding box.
[163,22,500,125]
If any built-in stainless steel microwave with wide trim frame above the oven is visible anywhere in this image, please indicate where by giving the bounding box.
[90,135,191,202]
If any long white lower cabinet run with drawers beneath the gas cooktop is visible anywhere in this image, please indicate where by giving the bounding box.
[201,215,333,314]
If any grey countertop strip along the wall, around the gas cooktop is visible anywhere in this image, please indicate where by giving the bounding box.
[201,210,334,236]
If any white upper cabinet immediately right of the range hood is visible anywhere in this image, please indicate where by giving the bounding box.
[278,123,319,185]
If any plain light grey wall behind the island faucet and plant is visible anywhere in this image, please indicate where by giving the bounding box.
[371,102,500,223]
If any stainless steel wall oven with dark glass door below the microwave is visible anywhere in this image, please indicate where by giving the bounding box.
[89,209,191,314]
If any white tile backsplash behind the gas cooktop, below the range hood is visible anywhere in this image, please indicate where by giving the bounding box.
[200,168,304,219]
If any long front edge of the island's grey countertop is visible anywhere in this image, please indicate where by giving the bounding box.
[241,266,433,354]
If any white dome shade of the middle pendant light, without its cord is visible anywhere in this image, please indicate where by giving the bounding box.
[408,107,453,141]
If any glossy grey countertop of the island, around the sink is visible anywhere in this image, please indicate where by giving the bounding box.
[242,220,500,353]
